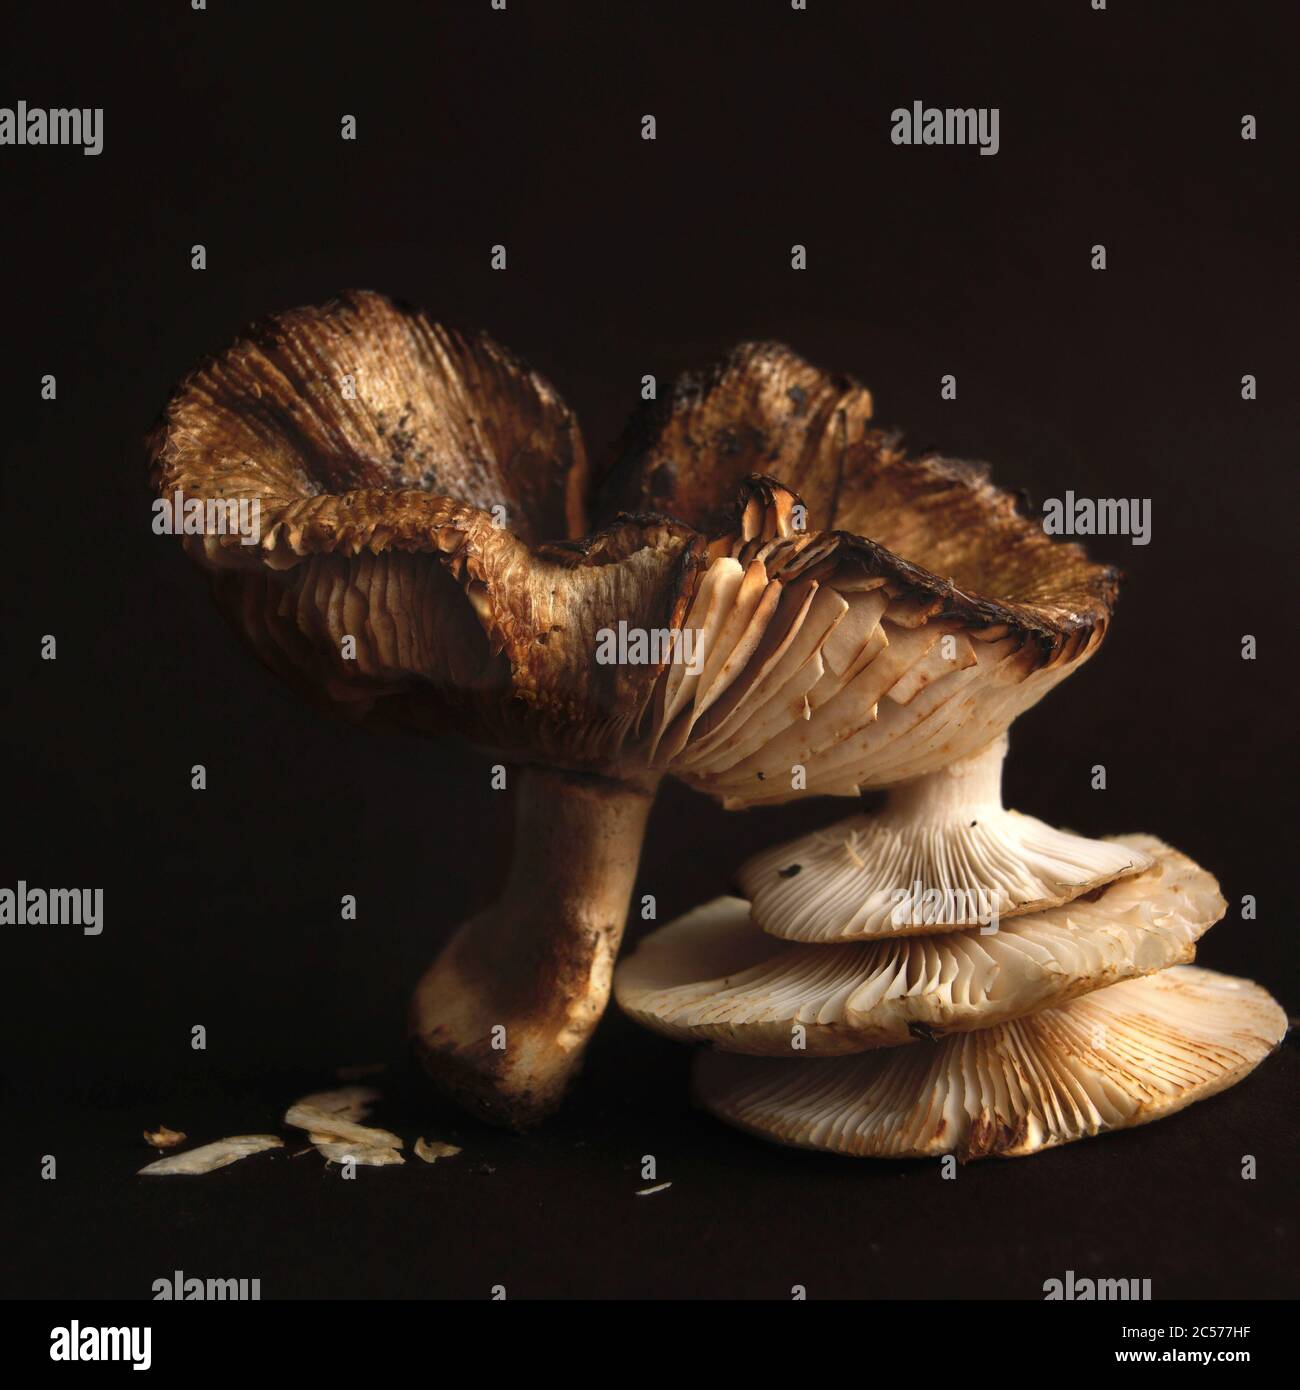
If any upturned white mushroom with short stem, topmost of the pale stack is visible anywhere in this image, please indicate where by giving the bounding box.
[736,738,1158,942]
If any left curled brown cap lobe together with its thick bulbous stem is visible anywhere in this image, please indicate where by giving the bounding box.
[150,293,702,1123]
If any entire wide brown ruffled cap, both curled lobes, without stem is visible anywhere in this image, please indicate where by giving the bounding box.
[152,292,1116,806]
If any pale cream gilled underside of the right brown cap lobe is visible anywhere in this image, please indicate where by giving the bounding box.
[649,511,1107,806]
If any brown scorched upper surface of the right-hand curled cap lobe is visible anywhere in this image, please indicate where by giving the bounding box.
[602,342,1119,649]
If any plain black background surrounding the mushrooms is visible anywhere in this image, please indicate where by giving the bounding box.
[0,0,1297,1298]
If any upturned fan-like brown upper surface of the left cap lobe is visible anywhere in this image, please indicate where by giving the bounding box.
[153,291,587,547]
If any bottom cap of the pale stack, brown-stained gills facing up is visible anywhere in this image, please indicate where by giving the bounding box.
[695,965,1286,1161]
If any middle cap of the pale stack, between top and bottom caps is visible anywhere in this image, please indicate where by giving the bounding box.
[615,835,1226,1058]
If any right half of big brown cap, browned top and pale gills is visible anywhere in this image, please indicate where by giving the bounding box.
[620,343,1119,808]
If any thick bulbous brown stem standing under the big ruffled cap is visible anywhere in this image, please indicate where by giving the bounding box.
[410,767,655,1127]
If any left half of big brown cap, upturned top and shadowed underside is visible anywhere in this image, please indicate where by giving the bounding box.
[150,292,699,767]
